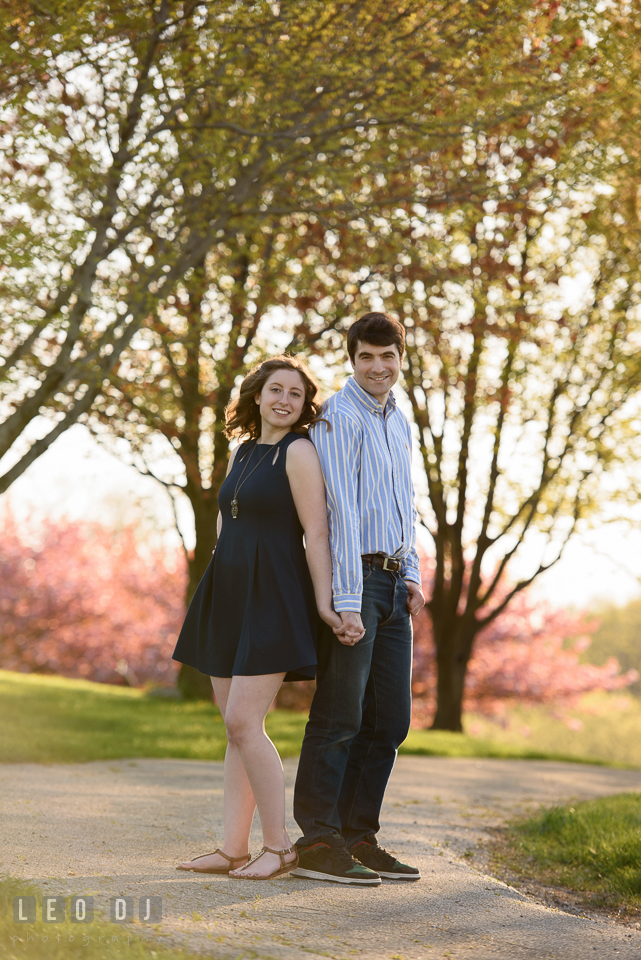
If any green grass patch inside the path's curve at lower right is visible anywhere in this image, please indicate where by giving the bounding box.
[495,793,641,913]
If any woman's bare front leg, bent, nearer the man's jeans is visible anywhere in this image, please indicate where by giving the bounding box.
[225,673,295,877]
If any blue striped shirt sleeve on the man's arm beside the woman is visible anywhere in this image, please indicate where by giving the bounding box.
[310,413,363,613]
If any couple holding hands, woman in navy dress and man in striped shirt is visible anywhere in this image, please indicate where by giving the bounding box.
[174,313,425,886]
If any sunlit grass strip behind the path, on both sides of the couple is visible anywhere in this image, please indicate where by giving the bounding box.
[0,670,641,767]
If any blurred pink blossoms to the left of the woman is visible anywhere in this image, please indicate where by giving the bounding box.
[0,515,187,685]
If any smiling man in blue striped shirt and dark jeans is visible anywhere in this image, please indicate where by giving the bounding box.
[293,313,425,886]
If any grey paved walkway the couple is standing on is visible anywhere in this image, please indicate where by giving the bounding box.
[0,757,641,960]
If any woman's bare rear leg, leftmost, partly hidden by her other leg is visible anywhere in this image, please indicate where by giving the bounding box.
[176,677,256,870]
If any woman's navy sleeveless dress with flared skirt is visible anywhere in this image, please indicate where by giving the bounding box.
[173,433,318,680]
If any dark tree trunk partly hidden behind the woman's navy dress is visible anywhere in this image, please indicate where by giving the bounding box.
[177,487,220,700]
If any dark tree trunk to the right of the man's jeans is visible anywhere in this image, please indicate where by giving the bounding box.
[431,622,474,733]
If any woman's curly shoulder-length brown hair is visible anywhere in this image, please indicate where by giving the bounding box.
[224,354,322,440]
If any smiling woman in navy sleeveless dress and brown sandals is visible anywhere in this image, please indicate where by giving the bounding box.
[169,356,341,880]
